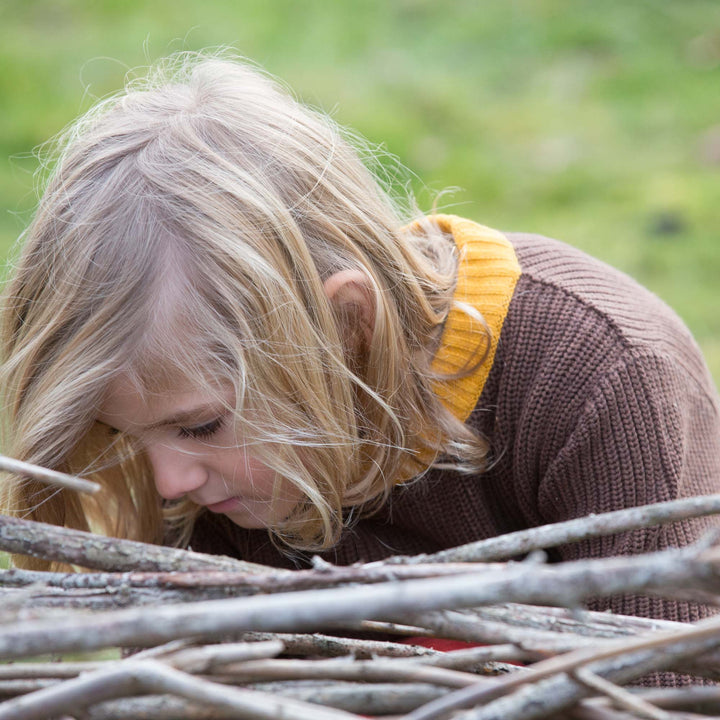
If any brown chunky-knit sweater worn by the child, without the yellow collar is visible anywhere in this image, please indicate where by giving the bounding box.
[192,229,720,621]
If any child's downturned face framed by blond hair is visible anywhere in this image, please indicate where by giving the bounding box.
[97,377,300,528]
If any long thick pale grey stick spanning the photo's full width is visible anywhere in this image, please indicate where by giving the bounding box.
[0,548,720,659]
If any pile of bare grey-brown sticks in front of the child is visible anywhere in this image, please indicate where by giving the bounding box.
[0,478,720,720]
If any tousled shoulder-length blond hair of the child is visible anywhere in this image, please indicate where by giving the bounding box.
[0,54,486,567]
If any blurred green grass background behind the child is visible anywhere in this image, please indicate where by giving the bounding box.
[0,0,720,382]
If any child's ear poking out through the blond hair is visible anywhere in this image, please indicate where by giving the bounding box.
[323,270,375,356]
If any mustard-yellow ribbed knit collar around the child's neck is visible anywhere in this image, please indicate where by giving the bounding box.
[429,215,521,421]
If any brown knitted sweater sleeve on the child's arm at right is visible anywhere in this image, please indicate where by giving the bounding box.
[538,349,720,621]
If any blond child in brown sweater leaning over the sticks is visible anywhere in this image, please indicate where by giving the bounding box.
[1,56,720,632]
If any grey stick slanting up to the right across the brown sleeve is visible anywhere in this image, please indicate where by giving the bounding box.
[382,495,720,565]
